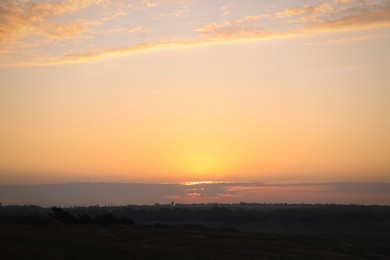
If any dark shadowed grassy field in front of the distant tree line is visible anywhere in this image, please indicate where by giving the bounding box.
[0,205,390,259]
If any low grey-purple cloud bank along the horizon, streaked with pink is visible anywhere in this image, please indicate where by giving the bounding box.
[0,183,390,206]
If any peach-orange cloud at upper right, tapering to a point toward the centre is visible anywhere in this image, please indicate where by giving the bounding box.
[196,1,390,40]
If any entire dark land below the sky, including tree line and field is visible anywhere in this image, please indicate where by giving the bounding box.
[0,205,390,259]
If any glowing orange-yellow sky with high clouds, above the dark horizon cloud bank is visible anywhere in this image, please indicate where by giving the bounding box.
[0,0,390,198]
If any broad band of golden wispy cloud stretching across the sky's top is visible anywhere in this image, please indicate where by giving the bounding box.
[0,0,390,66]
